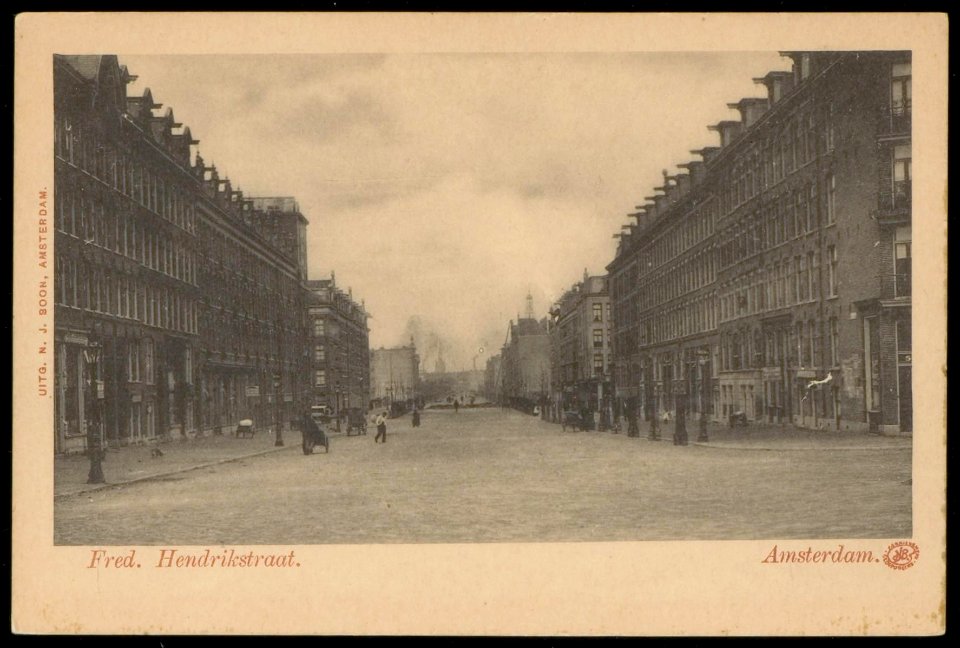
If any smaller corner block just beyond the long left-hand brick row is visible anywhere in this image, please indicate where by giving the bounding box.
[305,276,371,412]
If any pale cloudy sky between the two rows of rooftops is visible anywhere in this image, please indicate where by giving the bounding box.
[120,52,789,370]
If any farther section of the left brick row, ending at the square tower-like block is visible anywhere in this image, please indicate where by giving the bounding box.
[194,182,307,433]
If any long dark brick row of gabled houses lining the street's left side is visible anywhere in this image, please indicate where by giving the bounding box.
[54,55,312,452]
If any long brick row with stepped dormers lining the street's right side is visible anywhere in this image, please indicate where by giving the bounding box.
[608,52,912,433]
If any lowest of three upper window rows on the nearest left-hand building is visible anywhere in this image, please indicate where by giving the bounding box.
[54,255,198,333]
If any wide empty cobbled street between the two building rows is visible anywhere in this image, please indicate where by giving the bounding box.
[55,408,911,545]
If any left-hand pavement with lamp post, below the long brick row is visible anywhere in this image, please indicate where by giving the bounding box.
[53,430,300,499]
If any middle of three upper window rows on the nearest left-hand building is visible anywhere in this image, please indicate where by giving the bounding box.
[55,187,197,285]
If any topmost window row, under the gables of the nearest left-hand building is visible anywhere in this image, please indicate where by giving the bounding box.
[54,115,196,233]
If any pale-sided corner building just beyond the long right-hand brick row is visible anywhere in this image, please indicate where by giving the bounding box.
[551,271,614,412]
